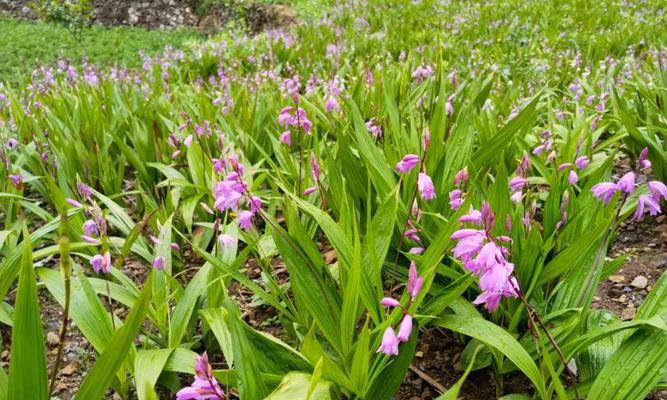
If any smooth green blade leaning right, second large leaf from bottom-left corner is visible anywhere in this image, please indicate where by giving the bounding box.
[76,274,152,400]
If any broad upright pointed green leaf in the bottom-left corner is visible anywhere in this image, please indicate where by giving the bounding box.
[8,226,49,400]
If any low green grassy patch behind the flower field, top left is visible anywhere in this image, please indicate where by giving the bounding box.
[0,15,201,85]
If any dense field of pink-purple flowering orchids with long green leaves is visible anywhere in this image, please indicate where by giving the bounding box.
[0,0,667,400]
